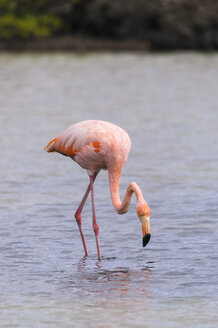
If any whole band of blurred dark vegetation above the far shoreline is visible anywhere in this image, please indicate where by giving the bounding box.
[0,0,218,49]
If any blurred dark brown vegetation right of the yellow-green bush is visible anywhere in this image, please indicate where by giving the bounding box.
[72,0,218,49]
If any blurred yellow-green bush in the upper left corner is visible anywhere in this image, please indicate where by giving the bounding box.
[0,0,73,39]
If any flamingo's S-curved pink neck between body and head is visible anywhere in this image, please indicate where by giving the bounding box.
[108,168,147,214]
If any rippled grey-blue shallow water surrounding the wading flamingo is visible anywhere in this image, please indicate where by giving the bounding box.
[0,53,218,328]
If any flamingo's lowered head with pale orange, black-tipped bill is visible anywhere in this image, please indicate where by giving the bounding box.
[136,202,151,247]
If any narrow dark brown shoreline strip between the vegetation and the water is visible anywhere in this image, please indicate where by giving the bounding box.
[0,35,218,53]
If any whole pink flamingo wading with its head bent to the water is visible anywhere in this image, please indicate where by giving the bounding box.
[44,120,151,260]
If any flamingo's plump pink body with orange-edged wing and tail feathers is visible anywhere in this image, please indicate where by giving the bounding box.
[45,120,131,173]
